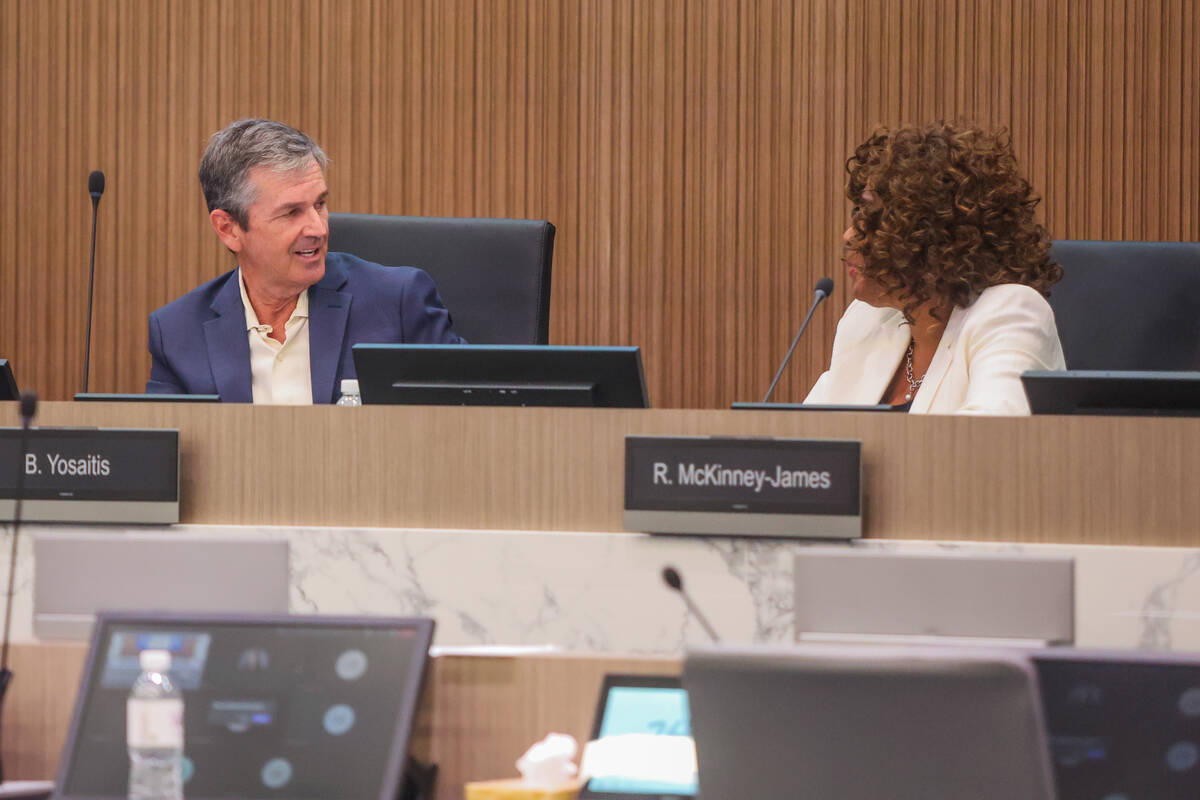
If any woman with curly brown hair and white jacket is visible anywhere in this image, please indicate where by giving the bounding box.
[805,124,1066,414]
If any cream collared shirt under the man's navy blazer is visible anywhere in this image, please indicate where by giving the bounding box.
[238,269,312,405]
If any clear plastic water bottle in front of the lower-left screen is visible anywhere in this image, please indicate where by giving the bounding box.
[125,650,184,800]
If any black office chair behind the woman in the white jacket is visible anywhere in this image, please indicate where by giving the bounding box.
[1050,240,1200,371]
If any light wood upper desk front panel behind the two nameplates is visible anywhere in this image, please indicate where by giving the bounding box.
[9,403,1200,546]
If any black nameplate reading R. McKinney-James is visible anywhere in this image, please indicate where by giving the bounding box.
[625,437,862,539]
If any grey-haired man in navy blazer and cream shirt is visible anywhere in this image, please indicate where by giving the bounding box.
[146,120,462,404]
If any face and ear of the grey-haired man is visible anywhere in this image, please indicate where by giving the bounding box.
[212,161,329,297]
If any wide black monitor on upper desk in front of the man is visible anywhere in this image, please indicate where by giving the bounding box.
[354,344,649,408]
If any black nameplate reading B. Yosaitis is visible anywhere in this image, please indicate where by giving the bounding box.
[0,428,179,522]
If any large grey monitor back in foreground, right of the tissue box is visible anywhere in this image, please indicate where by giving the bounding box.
[683,644,1054,800]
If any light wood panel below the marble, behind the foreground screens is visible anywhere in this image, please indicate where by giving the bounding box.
[0,644,680,800]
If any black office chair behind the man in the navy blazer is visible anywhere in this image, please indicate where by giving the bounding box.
[329,213,554,344]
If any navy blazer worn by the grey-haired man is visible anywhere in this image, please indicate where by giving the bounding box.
[146,253,462,403]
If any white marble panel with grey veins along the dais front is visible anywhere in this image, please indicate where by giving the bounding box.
[0,525,1200,654]
